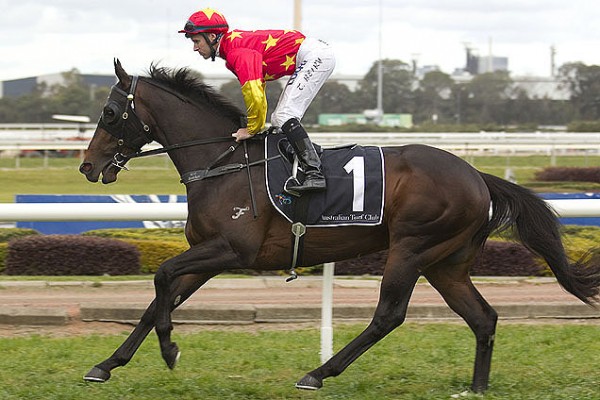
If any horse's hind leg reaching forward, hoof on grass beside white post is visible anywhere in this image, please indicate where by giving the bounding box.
[296,250,420,389]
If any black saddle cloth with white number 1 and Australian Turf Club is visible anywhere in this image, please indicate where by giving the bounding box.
[265,134,385,227]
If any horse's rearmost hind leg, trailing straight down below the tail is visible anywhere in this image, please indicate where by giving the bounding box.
[423,261,498,393]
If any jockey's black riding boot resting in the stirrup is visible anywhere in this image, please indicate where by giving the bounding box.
[281,118,326,192]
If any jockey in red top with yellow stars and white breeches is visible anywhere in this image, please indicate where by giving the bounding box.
[179,8,335,192]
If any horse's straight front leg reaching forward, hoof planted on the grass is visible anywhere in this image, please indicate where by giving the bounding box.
[83,273,215,382]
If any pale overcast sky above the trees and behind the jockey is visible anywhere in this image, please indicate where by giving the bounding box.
[0,0,600,80]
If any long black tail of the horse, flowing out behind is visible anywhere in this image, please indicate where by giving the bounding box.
[480,172,600,304]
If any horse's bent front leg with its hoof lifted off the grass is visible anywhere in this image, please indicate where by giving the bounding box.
[154,237,243,369]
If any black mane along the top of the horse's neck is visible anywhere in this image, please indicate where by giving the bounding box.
[149,64,245,122]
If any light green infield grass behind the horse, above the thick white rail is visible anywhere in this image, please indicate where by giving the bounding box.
[0,156,600,203]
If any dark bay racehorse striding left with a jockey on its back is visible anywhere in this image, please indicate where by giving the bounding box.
[80,60,600,392]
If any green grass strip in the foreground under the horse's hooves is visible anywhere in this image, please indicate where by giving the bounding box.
[0,324,600,400]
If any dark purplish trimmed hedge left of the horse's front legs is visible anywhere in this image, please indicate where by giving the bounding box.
[5,235,140,275]
